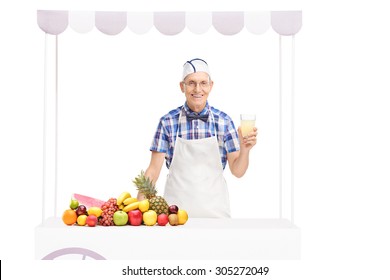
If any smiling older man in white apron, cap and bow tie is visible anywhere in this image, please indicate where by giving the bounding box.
[139,58,257,218]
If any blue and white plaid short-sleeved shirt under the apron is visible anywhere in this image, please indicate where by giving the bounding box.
[150,102,240,168]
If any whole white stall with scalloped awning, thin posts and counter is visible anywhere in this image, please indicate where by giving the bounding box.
[35,10,302,260]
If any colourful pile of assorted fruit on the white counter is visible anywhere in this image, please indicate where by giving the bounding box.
[62,177,188,227]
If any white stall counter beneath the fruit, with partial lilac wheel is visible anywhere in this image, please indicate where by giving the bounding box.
[35,218,301,260]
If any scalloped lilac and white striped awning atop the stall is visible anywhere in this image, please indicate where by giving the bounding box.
[37,10,302,36]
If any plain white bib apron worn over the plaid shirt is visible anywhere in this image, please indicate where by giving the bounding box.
[164,108,230,218]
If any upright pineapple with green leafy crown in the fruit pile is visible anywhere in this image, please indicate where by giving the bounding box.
[133,170,168,215]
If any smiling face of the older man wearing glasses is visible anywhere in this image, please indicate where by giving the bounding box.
[180,72,213,113]
